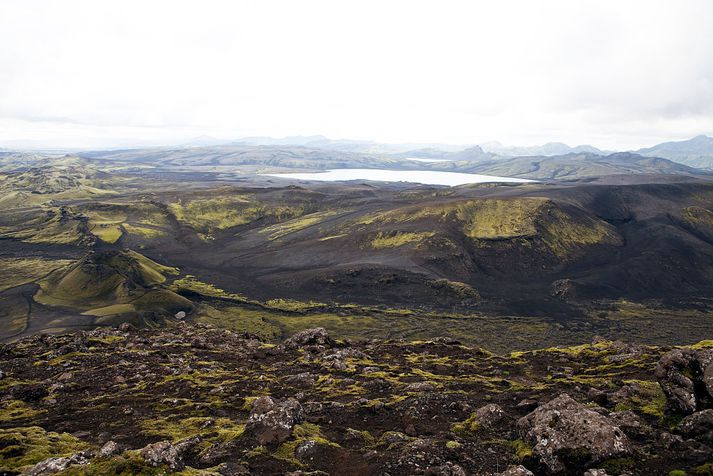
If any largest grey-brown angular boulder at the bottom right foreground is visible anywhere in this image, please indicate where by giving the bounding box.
[517,393,632,473]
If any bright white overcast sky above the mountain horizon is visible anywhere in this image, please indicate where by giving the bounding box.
[0,0,713,149]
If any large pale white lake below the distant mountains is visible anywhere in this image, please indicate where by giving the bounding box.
[260,169,536,186]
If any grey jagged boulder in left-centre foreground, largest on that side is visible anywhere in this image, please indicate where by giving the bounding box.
[245,396,304,445]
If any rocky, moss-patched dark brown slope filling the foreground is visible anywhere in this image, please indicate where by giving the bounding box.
[0,323,713,476]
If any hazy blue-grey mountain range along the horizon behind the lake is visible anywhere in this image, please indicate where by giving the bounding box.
[5,136,713,180]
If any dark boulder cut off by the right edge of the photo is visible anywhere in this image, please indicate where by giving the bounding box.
[656,349,713,415]
